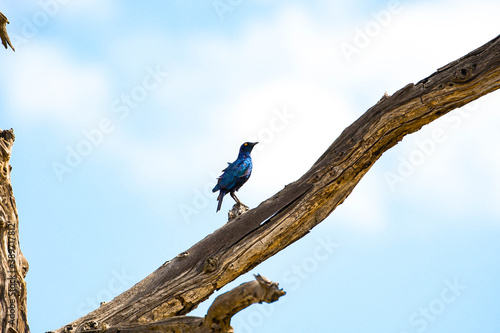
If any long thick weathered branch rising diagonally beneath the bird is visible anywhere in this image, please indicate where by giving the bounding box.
[47,36,500,332]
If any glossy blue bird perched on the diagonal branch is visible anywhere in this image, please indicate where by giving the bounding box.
[212,142,258,212]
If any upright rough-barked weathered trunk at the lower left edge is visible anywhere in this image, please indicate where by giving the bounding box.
[0,130,29,333]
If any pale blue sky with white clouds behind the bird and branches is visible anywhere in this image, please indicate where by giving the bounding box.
[0,0,500,333]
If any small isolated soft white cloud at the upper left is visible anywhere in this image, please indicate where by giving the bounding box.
[6,42,109,129]
